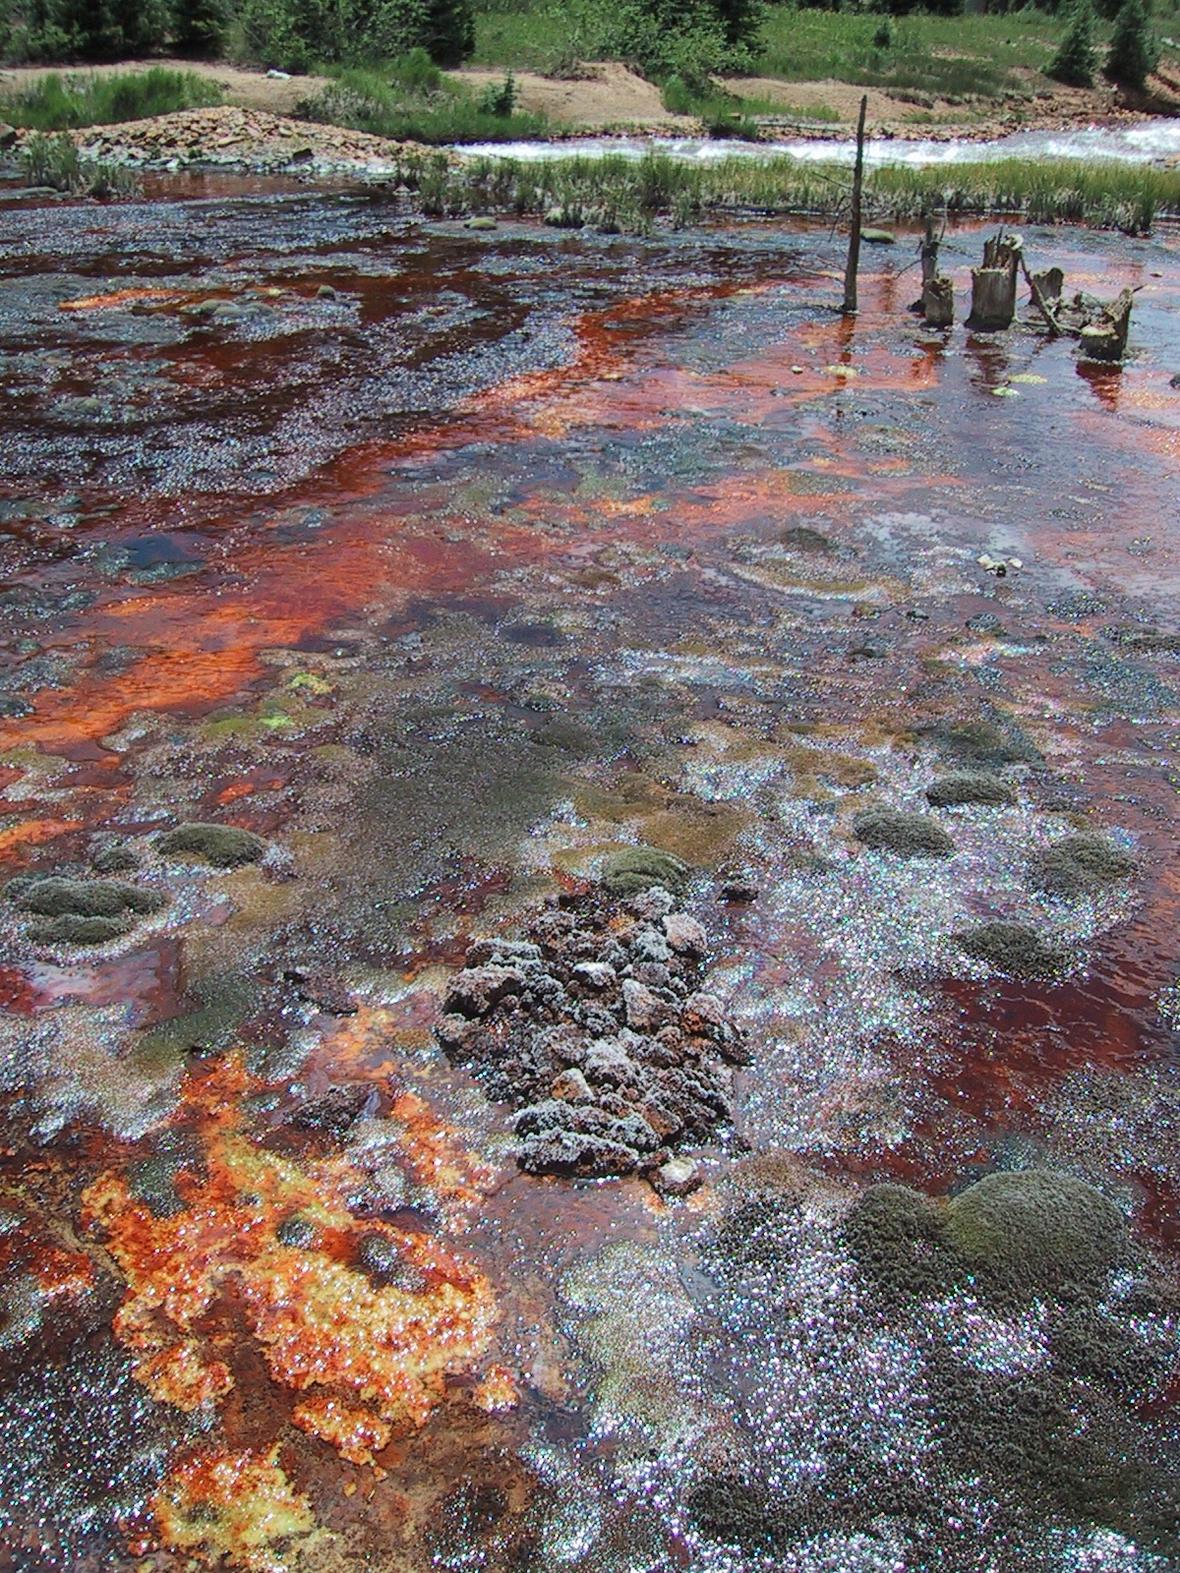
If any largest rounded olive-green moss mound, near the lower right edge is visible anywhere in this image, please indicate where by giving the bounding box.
[942,1169,1127,1293]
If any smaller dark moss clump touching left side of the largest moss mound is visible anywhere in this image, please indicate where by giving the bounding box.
[840,1184,952,1302]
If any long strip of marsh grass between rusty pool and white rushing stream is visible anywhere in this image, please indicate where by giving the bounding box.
[400,154,1180,233]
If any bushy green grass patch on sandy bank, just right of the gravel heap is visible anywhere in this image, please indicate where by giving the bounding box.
[299,58,549,145]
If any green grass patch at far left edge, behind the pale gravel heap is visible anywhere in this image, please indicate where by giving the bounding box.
[0,66,222,131]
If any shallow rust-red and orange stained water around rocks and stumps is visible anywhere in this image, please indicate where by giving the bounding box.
[0,179,1180,1573]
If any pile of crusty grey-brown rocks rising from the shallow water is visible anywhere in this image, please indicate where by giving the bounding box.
[436,886,744,1175]
